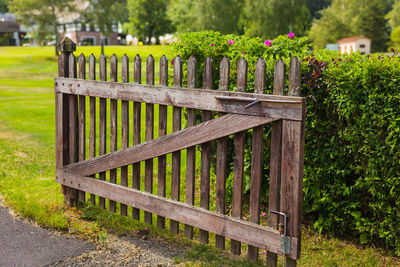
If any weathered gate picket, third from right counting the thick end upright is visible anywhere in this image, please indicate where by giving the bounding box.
[247,58,266,261]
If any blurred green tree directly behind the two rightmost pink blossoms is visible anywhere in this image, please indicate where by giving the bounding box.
[244,0,311,38]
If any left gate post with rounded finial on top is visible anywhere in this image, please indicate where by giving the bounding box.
[55,37,78,205]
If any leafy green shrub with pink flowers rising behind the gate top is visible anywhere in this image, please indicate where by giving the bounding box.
[171,31,310,93]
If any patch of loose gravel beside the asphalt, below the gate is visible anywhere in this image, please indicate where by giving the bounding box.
[49,235,186,266]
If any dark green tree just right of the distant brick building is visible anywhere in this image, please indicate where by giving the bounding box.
[127,0,174,44]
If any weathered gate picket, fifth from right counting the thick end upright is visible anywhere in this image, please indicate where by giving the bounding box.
[215,57,230,249]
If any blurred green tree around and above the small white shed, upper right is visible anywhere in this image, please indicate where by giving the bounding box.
[309,0,388,51]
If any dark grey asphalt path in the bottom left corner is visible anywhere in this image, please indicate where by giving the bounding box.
[0,203,95,266]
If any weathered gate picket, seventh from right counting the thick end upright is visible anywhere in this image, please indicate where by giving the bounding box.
[185,56,197,239]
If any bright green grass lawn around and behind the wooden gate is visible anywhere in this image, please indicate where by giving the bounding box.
[0,46,400,266]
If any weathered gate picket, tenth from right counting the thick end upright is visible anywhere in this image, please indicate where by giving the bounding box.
[144,55,154,224]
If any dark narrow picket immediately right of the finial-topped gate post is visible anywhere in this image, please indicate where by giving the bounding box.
[68,53,79,204]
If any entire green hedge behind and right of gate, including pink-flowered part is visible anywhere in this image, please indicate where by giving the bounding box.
[172,31,400,255]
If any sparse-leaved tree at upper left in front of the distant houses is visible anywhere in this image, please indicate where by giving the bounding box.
[8,0,74,44]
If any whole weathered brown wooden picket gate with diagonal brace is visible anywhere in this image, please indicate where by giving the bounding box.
[55,38,305,266]
